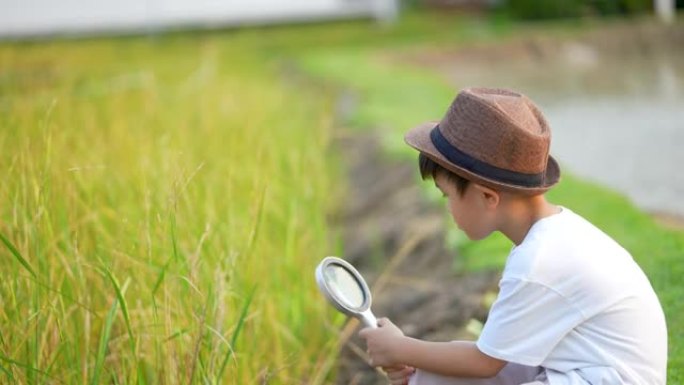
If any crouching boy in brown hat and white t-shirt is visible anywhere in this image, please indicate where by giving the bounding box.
[360,88,667,385]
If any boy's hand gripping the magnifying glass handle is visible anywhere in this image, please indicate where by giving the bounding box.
[359,318,404,367]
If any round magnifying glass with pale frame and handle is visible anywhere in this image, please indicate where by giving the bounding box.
[316,257,378,328]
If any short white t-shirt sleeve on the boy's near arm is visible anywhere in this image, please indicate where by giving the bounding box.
[477,279,584,366]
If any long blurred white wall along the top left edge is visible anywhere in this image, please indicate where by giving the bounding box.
[0,0,396,37]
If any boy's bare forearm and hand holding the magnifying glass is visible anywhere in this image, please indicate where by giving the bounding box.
[359,318,506,377]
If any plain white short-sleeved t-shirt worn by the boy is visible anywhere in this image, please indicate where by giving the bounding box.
[477,208,667,385]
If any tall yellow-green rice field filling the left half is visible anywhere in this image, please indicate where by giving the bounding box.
[0,33,341,384]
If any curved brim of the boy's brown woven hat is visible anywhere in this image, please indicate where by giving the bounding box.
[404,121,560,195]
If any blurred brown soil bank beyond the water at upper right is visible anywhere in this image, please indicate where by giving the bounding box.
[385,20,684,87]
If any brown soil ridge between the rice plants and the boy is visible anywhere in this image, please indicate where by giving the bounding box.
[335,134,499,385]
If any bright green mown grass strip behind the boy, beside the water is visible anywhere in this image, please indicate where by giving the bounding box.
[300,17,684,378]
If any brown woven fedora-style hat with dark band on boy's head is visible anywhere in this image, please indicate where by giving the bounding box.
[404,88,560,195]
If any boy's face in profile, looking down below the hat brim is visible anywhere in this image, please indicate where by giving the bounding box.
[435,173,498,240]
